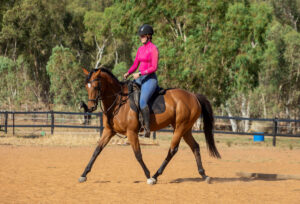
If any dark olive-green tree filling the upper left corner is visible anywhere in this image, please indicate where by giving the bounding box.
[0,0,65,100]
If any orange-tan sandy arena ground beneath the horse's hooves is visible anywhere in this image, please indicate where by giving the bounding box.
[0,139,300,204]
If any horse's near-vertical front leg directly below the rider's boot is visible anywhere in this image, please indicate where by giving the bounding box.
[127,131,151,183]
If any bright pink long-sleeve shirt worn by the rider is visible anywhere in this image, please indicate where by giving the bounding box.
[128,41,158,75]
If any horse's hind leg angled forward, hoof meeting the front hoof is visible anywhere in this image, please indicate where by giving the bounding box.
[152,130,182,182]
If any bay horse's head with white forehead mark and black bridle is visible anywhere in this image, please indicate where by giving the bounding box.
[83,68,101,112]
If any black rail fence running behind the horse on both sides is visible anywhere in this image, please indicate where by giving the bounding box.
[0,111,300,146]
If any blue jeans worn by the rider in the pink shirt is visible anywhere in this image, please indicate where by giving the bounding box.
[135,73,158,109]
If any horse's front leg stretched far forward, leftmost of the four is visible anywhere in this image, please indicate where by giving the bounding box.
[78,128,115,183]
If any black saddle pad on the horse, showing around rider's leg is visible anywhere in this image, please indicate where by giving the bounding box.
[130,91,166,114]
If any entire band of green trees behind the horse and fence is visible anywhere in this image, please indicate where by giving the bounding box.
[0,0,300,116]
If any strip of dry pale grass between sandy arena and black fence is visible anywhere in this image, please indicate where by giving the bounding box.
[0,128,300,150]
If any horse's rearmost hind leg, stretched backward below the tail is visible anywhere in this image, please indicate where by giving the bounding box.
[183,130,210,183]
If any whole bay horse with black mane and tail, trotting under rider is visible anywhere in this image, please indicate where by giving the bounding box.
[79,68,221,184]
